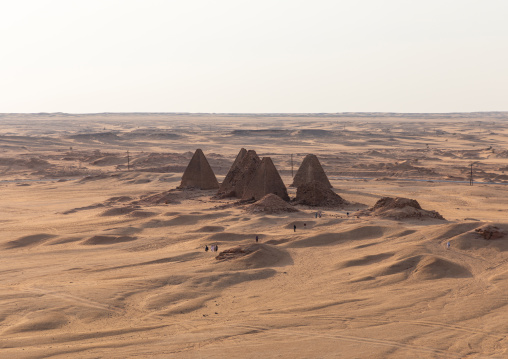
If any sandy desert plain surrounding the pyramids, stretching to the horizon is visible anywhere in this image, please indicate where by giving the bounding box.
[0,113,508,358]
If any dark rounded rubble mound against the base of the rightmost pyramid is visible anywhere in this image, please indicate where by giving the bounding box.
[295,181,349,207]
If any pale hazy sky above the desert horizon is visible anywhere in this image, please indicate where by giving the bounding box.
[0,0,508,113]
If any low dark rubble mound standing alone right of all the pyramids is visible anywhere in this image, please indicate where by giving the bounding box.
[355,197,445,220]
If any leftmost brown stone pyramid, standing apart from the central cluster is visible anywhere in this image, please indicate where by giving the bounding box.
[178,148,219,189]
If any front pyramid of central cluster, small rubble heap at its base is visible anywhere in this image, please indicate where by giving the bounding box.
[242,157,289,201]
